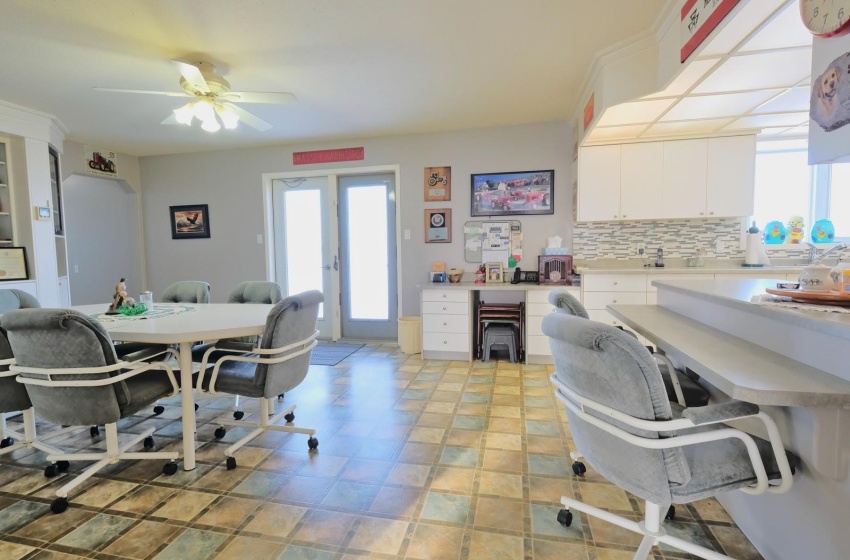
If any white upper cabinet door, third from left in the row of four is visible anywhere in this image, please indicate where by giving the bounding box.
[661,138,708,218]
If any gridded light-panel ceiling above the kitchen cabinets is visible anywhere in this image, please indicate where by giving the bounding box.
[585,0,812,143]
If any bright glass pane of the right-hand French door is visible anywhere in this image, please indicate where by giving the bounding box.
[347,185,389,320]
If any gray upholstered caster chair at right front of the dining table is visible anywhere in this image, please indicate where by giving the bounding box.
[196,290,324,469]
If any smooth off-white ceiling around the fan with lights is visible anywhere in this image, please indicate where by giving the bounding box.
[0,0,670,156]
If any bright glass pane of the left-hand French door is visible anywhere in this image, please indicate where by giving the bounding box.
[283,190,324,318]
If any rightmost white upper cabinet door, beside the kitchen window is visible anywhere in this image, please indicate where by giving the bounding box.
[705,136,756,217]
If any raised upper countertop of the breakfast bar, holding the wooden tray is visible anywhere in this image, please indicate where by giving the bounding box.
[652,279,850,340]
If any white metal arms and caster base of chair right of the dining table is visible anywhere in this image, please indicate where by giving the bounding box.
[196,330,319,468]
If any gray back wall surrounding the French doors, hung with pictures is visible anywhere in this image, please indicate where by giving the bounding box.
[139,122,573,315]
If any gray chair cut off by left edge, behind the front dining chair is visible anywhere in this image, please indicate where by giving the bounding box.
[0,289,78,460]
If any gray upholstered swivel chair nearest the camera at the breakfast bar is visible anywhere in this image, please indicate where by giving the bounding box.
[542,313,798,560]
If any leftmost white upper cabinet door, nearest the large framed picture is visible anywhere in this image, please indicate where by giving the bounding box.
[578,145,620,222]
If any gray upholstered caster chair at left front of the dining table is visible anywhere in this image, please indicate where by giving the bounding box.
[0,309,178,513]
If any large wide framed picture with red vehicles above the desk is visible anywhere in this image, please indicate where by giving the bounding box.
[471,169,555,216]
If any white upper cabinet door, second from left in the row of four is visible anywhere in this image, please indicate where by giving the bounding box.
[620,142,664,220]
